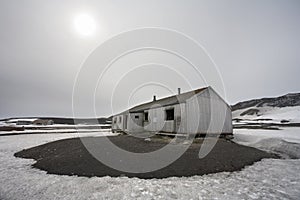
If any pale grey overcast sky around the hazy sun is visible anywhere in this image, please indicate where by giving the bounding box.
[0,0,300,118]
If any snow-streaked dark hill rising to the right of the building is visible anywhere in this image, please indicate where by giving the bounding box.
[232,93,300,127]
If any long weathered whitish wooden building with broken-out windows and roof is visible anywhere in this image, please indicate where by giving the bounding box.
[112,87,232,134]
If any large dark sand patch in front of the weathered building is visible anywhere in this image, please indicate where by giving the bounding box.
[15,135,279,179]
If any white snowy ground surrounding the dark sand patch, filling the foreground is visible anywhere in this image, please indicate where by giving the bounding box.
[0,129,300,199]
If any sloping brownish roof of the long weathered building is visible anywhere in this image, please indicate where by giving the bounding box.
[129,87,208,112]
